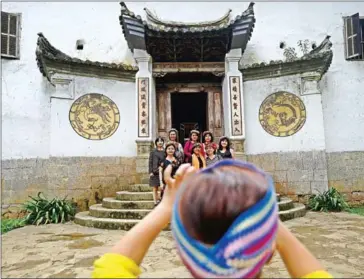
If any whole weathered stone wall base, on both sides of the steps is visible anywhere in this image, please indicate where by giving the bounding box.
[1,151,364,219]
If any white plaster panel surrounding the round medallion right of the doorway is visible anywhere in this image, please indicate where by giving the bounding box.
[244,75,325,154]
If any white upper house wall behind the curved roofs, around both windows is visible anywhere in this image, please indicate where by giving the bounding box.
[1,2,364,159]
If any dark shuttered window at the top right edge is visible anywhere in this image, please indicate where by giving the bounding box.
[344,13,364,60]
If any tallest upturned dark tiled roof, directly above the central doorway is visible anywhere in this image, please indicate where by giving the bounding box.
[119,2,255,62]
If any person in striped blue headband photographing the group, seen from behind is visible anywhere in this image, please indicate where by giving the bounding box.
[92,159,333,278]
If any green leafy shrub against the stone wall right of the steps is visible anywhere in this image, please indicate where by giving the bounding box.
[308,188,348,211]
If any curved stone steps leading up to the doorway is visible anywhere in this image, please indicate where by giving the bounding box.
[74,184,306,230]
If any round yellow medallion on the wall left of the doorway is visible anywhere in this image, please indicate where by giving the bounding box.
[69,93,120,140]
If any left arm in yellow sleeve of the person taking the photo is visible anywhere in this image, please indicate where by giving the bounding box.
[92,164,195,278]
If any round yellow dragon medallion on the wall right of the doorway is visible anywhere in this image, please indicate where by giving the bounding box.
[259,92,306,137]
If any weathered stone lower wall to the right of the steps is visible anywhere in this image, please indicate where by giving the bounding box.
[239,151,364,203]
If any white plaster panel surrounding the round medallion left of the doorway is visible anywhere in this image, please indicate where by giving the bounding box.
[50,77,137,157]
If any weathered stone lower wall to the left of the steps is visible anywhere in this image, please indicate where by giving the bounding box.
[1,157,147,219]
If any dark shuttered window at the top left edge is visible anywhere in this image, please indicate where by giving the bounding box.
[1,12,21,59]
